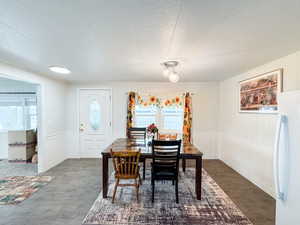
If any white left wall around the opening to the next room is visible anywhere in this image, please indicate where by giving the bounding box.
[0,63,67,172]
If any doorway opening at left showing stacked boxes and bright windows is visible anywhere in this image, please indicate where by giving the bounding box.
[0,77,40,178]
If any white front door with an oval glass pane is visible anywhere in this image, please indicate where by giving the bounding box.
[79,89,112,158]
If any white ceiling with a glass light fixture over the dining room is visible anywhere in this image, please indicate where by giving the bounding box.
[0,0,300,82]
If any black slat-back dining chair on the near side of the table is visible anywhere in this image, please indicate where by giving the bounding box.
[151,140,181,203]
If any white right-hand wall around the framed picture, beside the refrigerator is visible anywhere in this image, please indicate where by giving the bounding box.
[219,49,300,196]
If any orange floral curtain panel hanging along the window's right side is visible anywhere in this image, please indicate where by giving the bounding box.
[182,92,192,144]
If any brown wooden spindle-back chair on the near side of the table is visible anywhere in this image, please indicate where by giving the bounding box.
[110,150,141,203]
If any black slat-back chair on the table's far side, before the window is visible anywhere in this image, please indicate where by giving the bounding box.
[128,127,147,180]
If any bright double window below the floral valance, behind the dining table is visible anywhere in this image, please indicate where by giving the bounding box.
[134,105,183,133]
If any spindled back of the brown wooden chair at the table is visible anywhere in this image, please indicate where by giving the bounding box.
[111,150,141,179]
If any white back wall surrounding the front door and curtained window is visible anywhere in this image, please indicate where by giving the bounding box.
[67,82,219,158]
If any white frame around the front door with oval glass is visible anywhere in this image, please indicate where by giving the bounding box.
[76,87,113,158]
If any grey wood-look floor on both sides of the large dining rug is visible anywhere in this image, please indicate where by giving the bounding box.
[0,159,275,225]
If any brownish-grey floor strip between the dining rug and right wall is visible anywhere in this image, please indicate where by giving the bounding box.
[203,160,276,225]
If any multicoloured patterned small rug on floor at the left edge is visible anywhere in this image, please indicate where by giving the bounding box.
[0,176,52,205]
